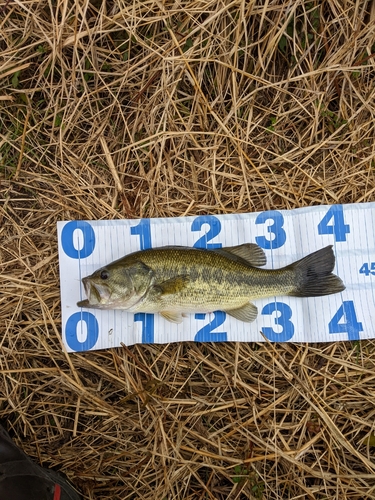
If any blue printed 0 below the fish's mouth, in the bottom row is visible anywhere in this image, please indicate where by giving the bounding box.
[65,311,99,351]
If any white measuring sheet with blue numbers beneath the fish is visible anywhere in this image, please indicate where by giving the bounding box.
[57,203,375,352]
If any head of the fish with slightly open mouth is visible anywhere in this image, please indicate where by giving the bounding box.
[77,260,152,309]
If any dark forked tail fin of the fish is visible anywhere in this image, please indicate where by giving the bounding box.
[288,245,345,297]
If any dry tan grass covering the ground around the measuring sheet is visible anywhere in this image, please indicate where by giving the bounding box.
[0,0,375,500]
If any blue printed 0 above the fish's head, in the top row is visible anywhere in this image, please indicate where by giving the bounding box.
[61,220,95,259]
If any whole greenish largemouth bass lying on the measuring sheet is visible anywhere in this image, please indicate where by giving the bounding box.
[77,243,345,323]
